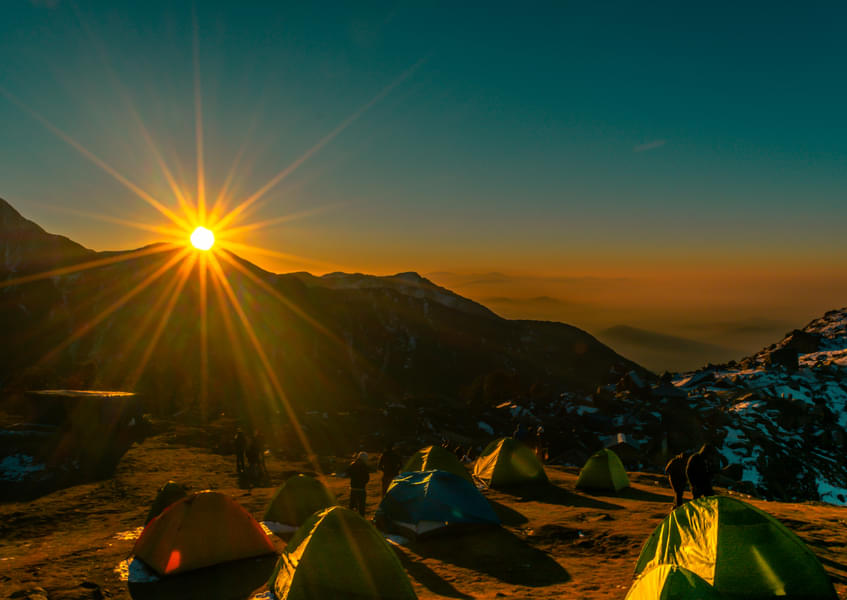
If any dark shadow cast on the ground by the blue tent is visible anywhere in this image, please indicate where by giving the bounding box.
[409,528,570,587]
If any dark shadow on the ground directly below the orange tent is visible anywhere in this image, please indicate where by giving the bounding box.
[129,554,278,600]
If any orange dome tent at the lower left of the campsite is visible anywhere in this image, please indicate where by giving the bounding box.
[133,492,274,575]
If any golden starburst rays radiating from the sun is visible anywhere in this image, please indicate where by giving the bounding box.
[0,36,423,472]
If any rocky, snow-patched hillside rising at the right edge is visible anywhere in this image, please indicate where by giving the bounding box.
[484,309,847,505]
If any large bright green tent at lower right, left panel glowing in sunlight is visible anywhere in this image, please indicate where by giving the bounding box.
[635,496,836,600]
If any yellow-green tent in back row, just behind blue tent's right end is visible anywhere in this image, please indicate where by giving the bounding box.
[474,438,547,487]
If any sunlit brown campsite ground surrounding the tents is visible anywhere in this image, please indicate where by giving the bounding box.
[0,426,847,600]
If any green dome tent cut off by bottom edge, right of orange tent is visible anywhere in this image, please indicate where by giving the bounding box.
[268,506,417,600]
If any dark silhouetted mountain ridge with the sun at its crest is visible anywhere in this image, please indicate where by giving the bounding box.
[0,199,641,438]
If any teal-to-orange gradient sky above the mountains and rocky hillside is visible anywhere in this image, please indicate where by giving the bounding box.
[0,0,847,368]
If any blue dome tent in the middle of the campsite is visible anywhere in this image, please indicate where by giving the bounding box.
[376,471,500,537]
